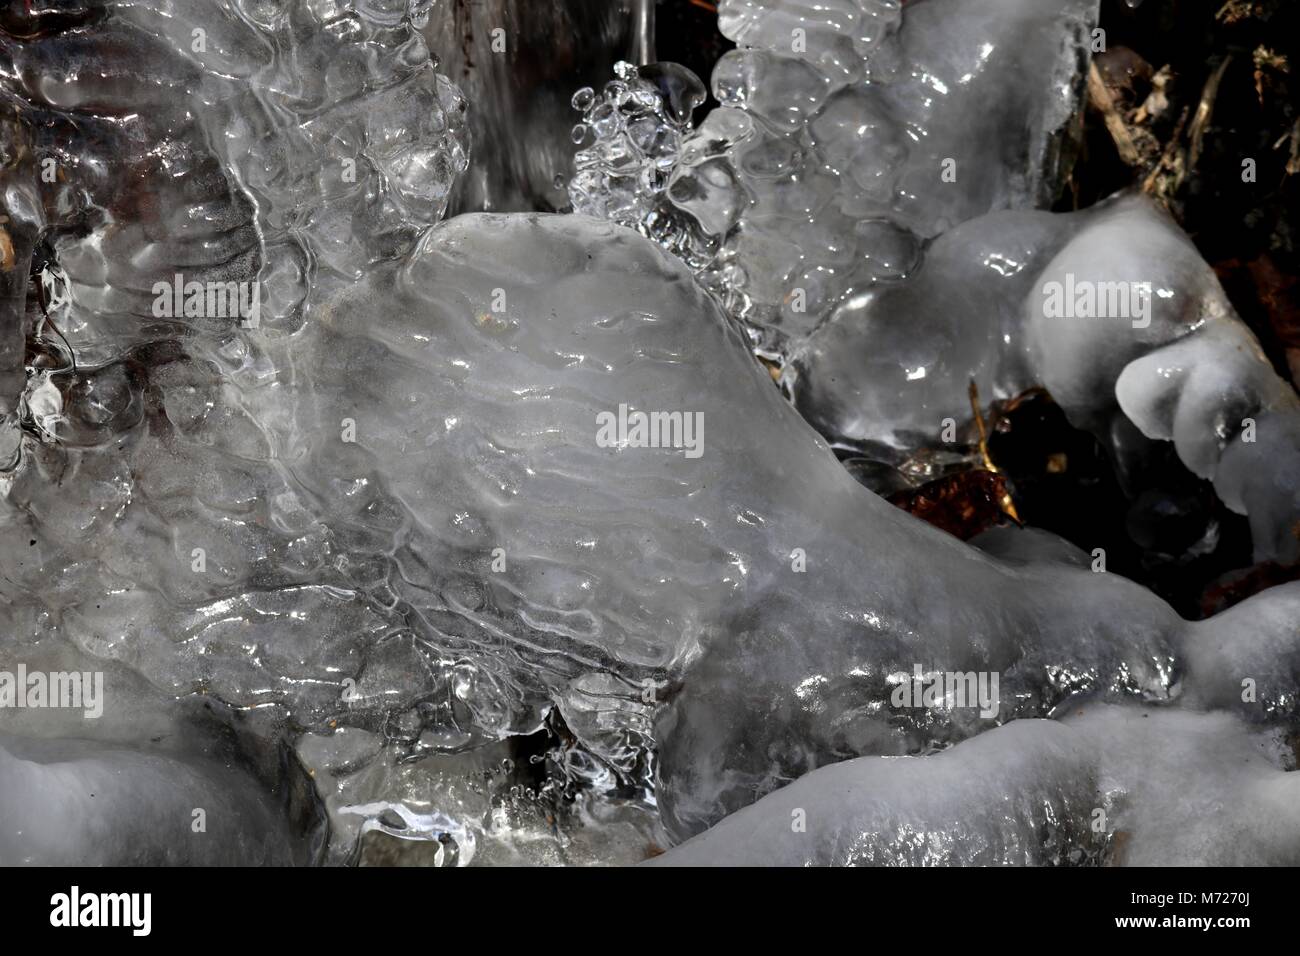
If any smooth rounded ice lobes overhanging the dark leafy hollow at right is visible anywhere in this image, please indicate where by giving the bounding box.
[785,195,1300,562]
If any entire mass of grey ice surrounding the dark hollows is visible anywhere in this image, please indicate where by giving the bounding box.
[0,0,1300,864]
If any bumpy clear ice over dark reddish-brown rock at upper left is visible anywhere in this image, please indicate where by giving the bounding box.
[0,0,467,367]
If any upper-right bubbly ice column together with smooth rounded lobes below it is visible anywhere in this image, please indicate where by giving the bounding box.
[571,0,1300,562]
